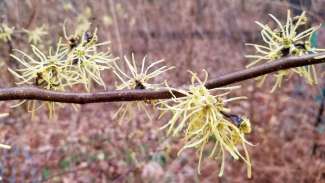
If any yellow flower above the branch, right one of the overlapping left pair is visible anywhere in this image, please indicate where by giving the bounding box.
[61,23,118,91]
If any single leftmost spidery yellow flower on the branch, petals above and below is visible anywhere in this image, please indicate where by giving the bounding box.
[8,39,78,117]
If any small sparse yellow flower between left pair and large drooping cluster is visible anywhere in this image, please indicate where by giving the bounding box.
[113,53,174,123]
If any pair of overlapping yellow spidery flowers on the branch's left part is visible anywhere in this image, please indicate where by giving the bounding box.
[9,26,116,117]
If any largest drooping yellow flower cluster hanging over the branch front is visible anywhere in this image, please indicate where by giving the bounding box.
[158,73,251,177]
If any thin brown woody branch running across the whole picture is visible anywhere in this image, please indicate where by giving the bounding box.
[0,52,325,104]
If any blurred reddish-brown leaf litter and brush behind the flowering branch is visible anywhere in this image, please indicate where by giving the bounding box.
[0,0,325,183]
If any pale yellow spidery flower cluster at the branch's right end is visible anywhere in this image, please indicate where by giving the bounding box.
[246,11,322,91]
